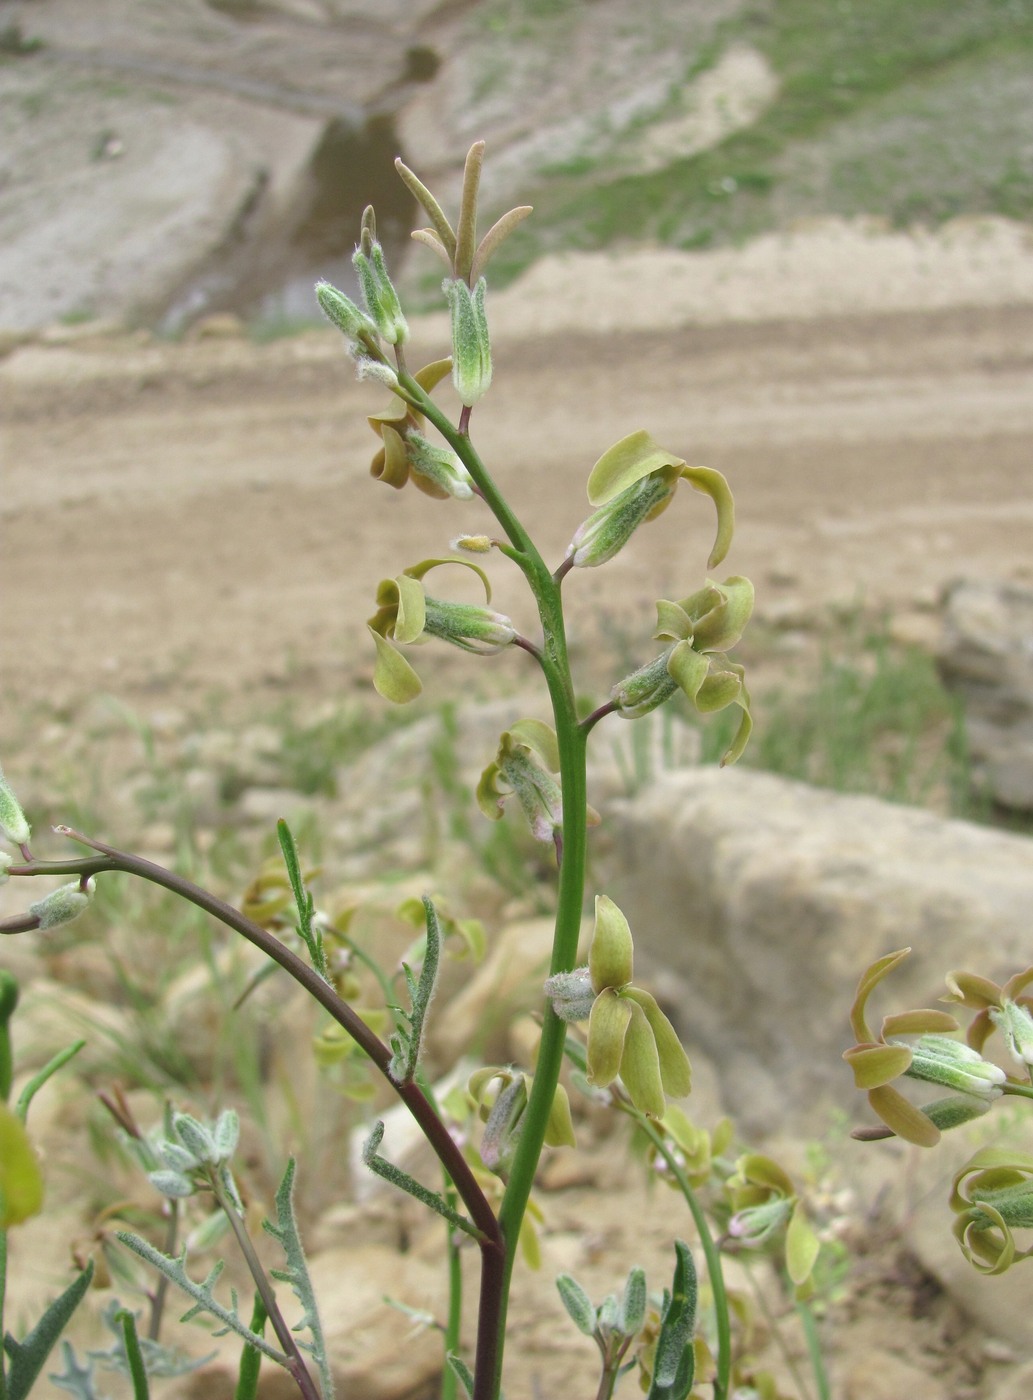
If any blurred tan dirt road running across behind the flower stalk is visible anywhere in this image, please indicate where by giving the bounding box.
[0,308,1033,722]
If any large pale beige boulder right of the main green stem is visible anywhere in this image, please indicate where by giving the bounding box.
[603,769,1033,1130]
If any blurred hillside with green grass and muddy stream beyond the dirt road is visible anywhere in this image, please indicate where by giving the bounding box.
[0,0,1033,330]
